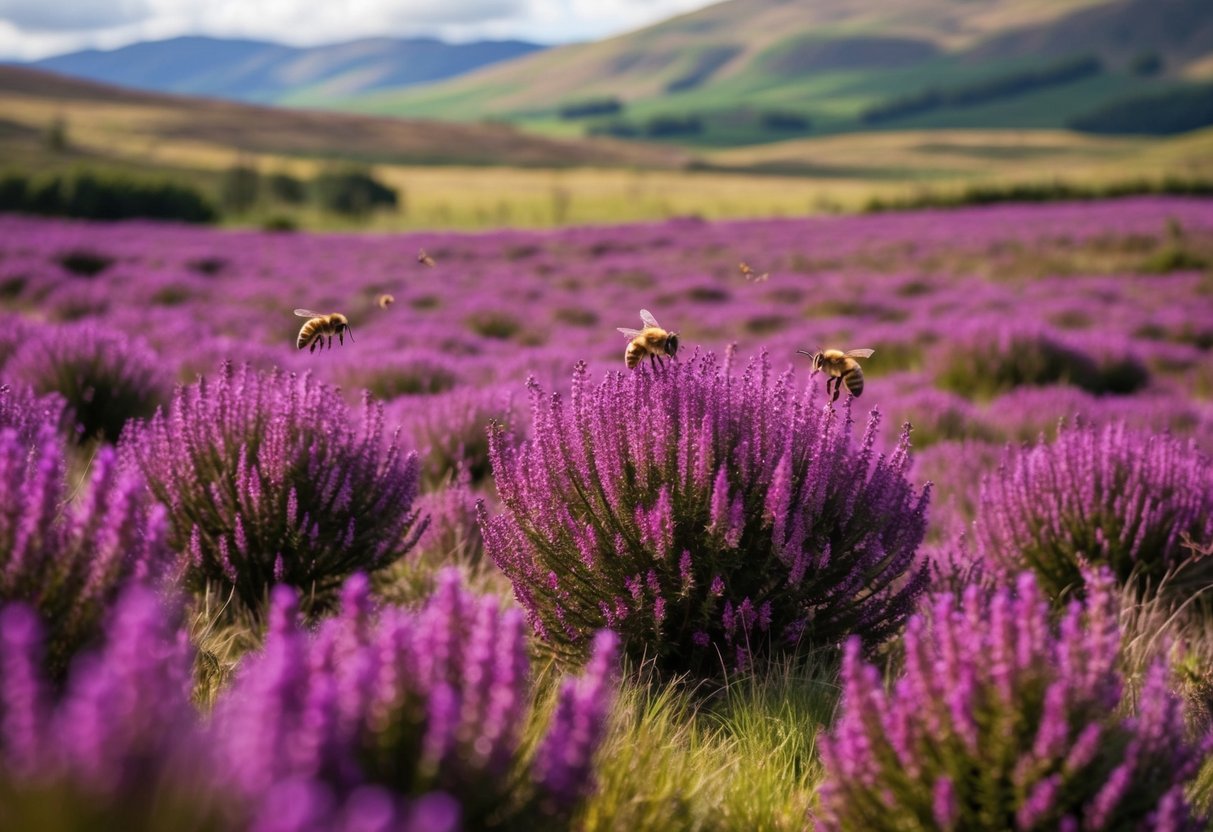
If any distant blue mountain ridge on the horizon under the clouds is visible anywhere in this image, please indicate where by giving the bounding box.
[29,36,545,103]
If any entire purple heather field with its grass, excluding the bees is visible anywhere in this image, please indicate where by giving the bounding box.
[0,199,1213,832]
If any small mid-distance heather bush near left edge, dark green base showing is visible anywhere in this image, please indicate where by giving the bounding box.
[5,324,170,441]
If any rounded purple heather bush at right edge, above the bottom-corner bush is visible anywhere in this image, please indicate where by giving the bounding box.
[974,423,1213,598]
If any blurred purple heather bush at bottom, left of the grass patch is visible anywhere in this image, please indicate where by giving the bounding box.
[215,570,615,827]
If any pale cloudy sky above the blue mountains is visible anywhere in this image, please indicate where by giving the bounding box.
[0,0,713,61]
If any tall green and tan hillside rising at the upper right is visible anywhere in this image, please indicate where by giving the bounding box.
[322,0,1213,147]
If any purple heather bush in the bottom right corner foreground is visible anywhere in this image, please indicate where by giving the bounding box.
[818,572,1213,831]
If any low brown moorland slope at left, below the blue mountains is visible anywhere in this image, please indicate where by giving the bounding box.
[0,67,687,167]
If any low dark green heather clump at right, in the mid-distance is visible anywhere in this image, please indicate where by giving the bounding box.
[934,326,1150,399]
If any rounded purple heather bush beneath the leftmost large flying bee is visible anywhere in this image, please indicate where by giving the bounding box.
[126,364,425,618]
